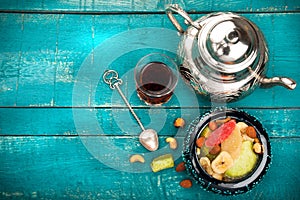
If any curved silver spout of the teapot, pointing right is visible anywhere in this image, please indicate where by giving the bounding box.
[260,77,297,90]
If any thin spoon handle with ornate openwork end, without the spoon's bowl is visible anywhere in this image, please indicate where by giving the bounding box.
[103,70,145,131]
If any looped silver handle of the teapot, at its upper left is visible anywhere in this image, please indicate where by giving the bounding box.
[166,4,201,33]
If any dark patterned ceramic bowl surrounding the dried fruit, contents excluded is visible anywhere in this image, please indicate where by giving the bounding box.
[183,108,271,195]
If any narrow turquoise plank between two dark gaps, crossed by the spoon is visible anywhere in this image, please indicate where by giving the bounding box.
[0,107,300,137]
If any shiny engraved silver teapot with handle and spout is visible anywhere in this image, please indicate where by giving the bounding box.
[166,4,296,102]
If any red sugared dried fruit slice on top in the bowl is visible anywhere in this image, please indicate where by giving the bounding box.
[205,120,236,147]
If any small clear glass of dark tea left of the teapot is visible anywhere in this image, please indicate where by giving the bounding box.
[134,53,178,105]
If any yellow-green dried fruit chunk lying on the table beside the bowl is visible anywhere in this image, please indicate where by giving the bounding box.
[151,154,174,172]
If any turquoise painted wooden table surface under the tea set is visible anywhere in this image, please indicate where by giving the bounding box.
[0,0,300,199]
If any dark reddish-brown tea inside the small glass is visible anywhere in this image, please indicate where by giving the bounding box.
[137,62,177,104]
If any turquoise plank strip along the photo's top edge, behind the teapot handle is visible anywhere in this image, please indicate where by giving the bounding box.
[1,0,300,12]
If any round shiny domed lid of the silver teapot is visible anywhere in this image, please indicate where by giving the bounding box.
[198,13,266,73]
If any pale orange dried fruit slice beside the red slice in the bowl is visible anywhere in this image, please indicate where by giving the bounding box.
[221,126,243,160]
